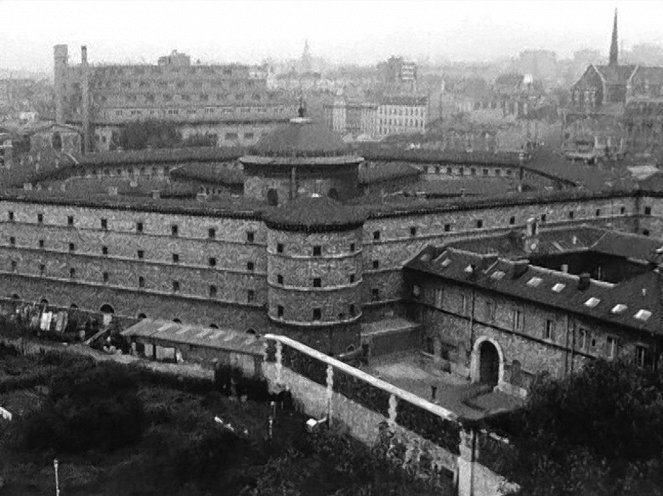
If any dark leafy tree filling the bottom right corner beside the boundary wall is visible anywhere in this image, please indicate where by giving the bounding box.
[493,360,663,496]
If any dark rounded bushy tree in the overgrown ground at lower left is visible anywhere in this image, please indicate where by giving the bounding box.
[23,363,144,453]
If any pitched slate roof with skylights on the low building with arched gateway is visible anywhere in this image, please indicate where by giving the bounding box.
[406,246,663,335]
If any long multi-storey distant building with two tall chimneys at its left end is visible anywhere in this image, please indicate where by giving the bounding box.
[54,45,296,150]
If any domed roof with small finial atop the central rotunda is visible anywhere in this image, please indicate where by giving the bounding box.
[255,117,348,157]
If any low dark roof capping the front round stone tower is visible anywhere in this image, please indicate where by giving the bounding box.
[264,196,366,232]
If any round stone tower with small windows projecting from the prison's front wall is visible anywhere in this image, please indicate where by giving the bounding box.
[265,196,366,354]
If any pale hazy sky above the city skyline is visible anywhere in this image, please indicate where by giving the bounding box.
[0,0,663,72]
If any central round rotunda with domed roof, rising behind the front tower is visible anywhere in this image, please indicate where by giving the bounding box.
[240,117,363,205]
